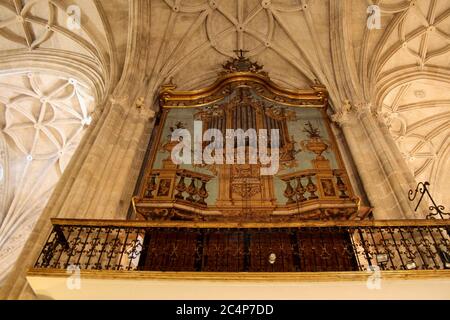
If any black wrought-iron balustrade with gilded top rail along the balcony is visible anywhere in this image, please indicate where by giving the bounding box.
[34,219,450,272]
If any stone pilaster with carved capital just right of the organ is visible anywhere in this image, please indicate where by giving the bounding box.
[332,102,416,219]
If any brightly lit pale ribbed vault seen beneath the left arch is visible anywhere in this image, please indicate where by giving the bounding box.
[0,72,95,282]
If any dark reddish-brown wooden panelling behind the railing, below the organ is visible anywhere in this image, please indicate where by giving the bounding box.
[140,228,358,272]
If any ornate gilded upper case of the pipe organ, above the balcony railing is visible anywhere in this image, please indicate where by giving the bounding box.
[133,57,359,223]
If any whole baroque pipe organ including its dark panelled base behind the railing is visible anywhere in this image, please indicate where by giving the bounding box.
[127,56,366,272]
